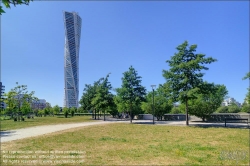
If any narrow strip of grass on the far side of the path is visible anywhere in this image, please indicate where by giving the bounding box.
[0,116,92,131]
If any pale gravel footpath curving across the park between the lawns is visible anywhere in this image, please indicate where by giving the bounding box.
[0,120,249,143]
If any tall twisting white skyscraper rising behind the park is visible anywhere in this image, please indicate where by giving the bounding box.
[63,12,82,108]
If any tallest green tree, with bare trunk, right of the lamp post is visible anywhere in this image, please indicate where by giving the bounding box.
[163,41,216,125]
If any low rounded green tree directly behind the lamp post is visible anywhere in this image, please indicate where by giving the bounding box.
[141,85,173,120]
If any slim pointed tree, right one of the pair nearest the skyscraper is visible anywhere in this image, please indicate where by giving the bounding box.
[91,73,113,120]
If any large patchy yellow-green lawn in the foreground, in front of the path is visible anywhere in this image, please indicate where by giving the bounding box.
[1,123,249,165]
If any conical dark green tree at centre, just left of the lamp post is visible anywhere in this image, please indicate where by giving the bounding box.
[116,66,146,123]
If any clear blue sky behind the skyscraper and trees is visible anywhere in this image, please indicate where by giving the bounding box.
[1,1,249,106]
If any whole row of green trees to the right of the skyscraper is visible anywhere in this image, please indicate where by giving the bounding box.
[79,41,249,125]
